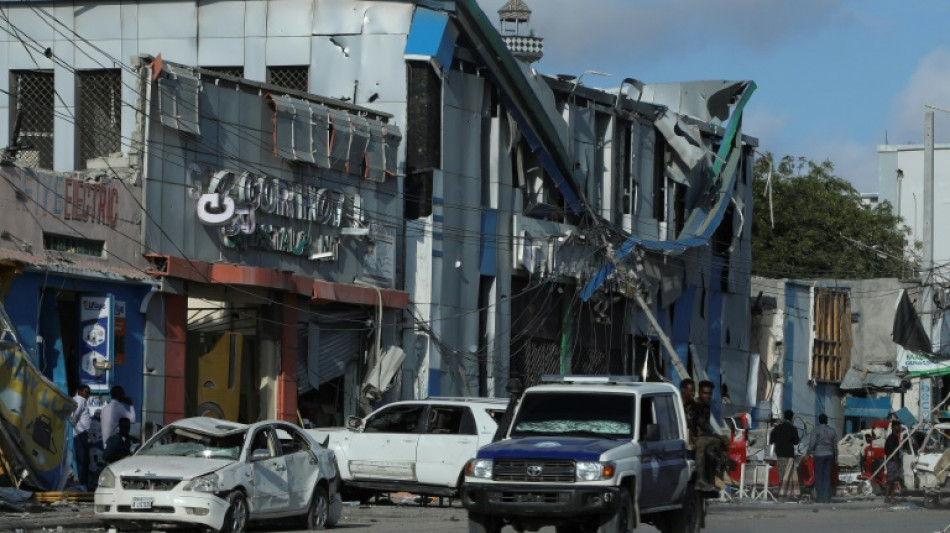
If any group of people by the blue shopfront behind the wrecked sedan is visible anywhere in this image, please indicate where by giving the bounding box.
[69,385,138,487]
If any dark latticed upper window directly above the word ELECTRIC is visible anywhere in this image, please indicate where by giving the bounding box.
[76,69,122,168]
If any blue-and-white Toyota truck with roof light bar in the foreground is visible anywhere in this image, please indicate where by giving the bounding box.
[461,376,705,533]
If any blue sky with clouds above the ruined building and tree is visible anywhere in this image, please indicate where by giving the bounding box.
[478,0,950,193]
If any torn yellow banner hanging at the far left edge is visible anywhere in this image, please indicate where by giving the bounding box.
[0,343,75,490]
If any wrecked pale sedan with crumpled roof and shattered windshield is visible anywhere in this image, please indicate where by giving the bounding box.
[95,417,343,533]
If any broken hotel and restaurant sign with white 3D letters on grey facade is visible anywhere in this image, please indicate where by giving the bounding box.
[189,169,362,260]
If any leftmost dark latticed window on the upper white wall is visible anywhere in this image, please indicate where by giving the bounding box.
[10,70,55,169]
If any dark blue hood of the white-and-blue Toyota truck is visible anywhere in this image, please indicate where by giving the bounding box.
[478,437,630,461]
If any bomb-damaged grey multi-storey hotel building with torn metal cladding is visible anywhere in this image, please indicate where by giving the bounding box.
[0,0,759,486]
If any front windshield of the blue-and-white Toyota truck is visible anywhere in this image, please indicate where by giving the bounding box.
[511,392,635,439]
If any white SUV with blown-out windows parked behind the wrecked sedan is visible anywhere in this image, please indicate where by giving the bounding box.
[309,398,507,496]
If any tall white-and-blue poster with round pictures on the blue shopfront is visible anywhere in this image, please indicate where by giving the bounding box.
[79,296,114,392]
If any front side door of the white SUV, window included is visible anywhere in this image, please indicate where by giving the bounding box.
[346,404,425,481]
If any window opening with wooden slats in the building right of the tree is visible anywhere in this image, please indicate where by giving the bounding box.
[811,287,852,383]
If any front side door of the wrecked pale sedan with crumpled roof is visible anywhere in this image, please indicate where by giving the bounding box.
[248,426,290,514]
